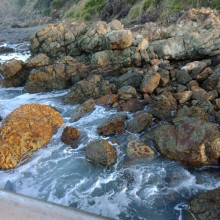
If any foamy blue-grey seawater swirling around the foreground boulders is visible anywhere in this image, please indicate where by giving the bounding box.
[0,47,220,220]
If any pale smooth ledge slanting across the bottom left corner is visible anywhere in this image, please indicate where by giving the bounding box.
[0,190,109,220]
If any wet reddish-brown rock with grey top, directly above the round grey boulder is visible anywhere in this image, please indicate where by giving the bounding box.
[97,114,128,136]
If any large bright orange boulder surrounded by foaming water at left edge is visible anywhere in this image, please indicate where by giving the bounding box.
[0,104,64,169]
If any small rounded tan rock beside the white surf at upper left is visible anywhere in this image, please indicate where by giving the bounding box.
[25,53,50,68]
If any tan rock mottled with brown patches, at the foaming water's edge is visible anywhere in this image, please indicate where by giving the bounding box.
[127,141,156,159]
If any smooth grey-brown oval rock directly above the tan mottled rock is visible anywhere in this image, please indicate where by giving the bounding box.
[127,113,153,134]
